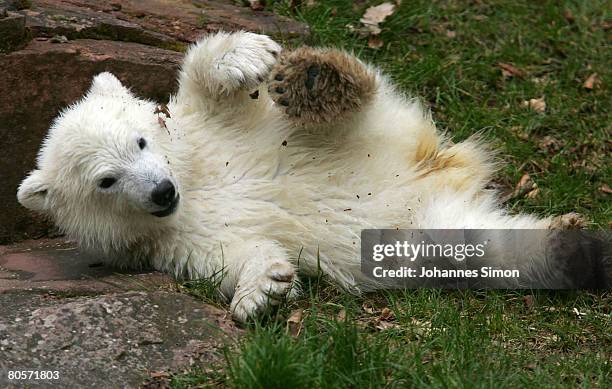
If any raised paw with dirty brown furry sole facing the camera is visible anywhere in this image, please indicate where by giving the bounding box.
[268,48,375,124]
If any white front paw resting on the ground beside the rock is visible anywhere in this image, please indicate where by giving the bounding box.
[230,262,297,322]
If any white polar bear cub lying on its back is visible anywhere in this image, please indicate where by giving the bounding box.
[18,32,580,320]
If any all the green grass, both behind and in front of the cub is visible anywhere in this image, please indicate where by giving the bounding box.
[172,0,612,388]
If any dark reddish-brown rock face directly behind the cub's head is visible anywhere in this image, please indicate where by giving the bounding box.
[0,39,182,243]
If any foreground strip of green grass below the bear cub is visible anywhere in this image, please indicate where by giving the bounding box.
[172,279,612,388]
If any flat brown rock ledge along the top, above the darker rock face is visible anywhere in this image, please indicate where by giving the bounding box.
[0,0,309,51]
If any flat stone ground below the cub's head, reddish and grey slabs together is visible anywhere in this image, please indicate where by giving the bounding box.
[0,239,242,388]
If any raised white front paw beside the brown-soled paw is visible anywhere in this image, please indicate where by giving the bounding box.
[183,32,281,95]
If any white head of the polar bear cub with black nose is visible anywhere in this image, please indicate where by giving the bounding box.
[17,73,180,250]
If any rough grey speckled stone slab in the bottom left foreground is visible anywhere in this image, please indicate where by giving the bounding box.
[0,291,241,388]
